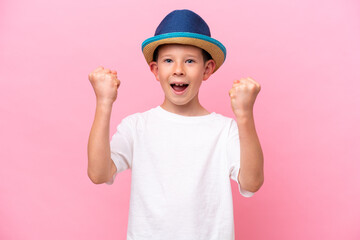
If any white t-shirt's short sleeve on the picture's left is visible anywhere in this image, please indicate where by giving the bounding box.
[106,117,133,185]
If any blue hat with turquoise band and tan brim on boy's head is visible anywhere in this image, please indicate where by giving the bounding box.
[141,9,226,72]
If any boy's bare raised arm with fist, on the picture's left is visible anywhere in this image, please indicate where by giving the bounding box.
[87,67,120,184]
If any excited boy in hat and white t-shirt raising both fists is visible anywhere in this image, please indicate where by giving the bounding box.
[88,10,264,240]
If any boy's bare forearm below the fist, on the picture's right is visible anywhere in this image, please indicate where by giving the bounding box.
[236,113,264,192]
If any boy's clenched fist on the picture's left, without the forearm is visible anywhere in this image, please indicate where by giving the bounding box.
[89,66,120,104]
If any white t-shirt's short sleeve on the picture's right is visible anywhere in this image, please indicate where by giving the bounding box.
[226,119,254,197]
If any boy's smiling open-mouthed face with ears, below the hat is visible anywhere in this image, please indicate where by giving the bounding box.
[150,44,215,107]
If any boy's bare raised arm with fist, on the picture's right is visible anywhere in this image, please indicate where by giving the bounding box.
[229,78,264,192]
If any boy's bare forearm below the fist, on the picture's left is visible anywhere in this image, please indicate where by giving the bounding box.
[88,102,112,184]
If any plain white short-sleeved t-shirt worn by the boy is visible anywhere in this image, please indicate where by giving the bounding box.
[107,106,254,240]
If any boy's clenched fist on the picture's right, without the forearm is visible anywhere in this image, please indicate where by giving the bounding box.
[229,78,261,115]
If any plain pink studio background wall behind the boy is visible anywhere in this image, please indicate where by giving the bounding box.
[0,0,360,240]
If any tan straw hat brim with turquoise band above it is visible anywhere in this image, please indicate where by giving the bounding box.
[142,32,226,72]
